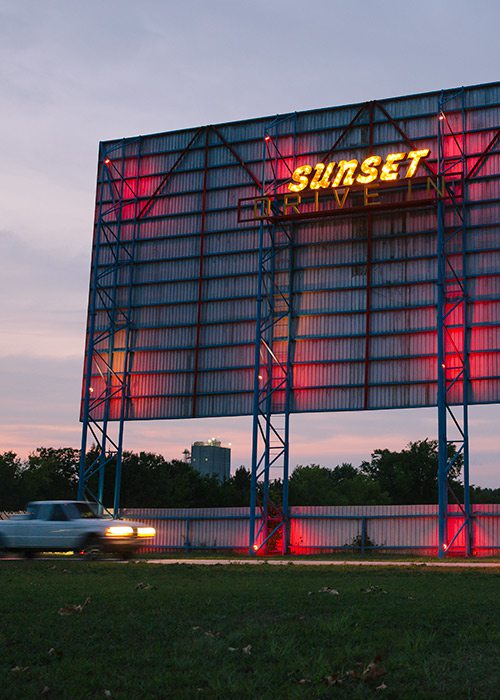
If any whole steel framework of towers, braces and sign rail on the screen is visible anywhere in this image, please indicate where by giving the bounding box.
[78,88,500,557]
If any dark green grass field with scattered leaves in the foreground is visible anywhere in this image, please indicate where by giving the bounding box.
[0,559,500,700]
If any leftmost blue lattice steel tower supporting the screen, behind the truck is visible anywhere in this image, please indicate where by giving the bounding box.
[78,139,141,515]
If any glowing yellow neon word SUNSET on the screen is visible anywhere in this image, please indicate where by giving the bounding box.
[288,148,430,192]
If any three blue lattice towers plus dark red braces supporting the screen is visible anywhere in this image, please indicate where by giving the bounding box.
[78,91,500,556]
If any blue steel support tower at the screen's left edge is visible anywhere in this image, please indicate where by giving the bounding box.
[78,139,136,515]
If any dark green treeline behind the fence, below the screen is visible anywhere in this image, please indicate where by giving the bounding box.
[0,440,500,511]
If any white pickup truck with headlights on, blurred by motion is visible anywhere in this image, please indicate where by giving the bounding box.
[0,501,156,559]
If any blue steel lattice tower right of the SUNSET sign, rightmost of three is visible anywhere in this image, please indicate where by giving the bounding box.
[437,89,472,557]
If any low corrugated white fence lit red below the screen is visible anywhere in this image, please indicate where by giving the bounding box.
[122,505,500,556]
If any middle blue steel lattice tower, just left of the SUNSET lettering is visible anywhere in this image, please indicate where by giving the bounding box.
[249,117,293,554]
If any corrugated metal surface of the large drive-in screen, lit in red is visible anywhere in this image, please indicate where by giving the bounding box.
[85,84,500,419]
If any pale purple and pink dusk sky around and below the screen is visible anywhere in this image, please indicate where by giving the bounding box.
[0,0,500,487]
